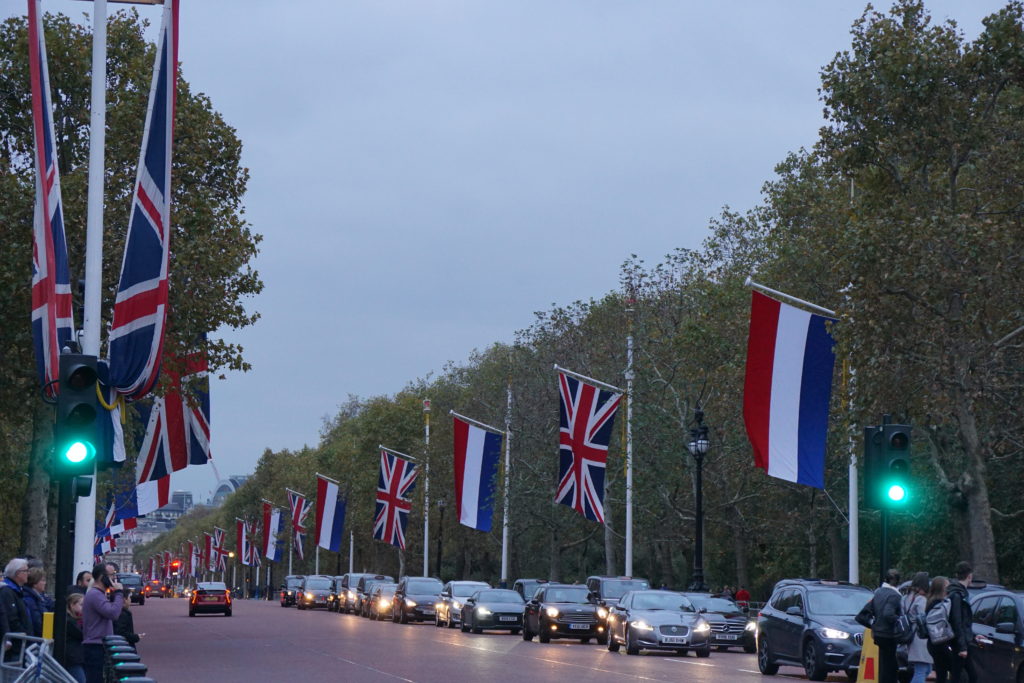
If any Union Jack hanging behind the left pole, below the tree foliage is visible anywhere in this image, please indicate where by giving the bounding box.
[136,352,211,483]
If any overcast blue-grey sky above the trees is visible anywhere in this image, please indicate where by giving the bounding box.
[0,0,1005,501]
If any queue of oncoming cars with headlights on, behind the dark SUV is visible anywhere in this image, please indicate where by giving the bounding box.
[280,573,755,656]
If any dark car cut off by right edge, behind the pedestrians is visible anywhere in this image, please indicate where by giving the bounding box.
[970,588,1024,683]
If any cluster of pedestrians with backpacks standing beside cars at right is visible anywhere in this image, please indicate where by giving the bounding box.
[857,562,978,683]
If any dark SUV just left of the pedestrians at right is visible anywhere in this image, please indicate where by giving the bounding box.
[758,579,872,681]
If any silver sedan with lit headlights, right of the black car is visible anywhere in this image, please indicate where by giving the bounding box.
[608,591,711,657]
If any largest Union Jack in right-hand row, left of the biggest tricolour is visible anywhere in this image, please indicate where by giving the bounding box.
[555,373,623,524]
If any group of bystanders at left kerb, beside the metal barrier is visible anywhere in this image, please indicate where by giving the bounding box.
[0,557,140,683]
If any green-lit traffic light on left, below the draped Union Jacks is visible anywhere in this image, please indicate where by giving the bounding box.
[53,353,99,478]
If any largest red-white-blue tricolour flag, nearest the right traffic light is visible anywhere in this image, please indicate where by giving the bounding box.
[743,292,836,488]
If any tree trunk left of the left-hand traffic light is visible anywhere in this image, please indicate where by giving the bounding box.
[20,401,52,565]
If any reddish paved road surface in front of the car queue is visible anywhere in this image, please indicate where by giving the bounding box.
[132,599,846,683]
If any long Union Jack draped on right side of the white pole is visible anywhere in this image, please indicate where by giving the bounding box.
[110,0,178,399]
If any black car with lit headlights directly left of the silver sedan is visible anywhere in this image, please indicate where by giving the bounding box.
[522,584,607,645]
